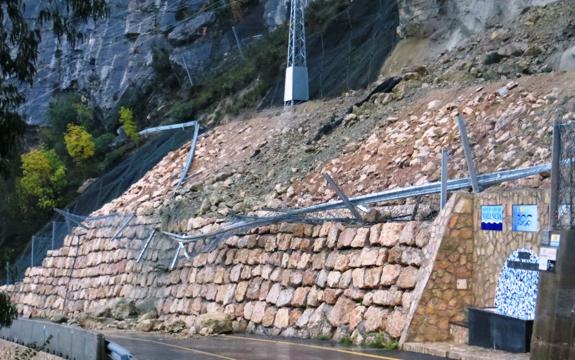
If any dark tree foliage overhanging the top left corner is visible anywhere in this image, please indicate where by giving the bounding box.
[0,0,108,175]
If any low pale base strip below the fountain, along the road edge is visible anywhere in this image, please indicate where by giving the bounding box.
[402,342,529,360]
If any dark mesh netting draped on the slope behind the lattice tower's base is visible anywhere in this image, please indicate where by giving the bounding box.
[264,0,399,105]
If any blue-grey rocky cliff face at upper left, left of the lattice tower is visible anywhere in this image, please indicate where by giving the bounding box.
[22,0,286,124]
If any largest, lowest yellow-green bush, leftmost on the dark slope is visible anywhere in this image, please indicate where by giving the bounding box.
[18,149,67,210]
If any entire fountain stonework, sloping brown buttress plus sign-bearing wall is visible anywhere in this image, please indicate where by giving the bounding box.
[401,189,549,343]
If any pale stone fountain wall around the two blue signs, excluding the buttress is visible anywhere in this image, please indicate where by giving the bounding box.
[471,189,550,307]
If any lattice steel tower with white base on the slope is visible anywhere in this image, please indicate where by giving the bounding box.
[284,0,309,106]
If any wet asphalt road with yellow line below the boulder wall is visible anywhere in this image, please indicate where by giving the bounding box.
[104,331,440,360]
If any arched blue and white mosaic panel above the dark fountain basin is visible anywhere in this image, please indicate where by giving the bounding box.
[495,249,539,320]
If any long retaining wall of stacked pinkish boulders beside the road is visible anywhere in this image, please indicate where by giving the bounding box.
[3,217,429,343]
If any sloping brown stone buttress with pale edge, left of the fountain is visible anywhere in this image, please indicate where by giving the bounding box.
[401,192,473,343]
